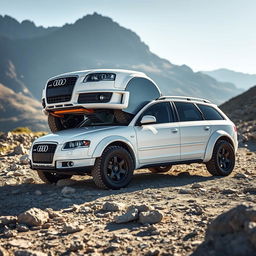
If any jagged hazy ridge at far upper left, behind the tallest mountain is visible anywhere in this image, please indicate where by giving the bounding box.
[0,15,58,39]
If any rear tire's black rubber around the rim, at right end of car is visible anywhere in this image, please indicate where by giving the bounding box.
[206,140,236,176]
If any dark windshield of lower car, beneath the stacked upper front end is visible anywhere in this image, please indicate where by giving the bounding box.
[78,109,133,127]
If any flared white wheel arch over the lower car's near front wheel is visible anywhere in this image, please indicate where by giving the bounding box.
[93,136,138,169]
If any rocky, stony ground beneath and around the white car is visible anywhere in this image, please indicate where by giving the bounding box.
[0,133,256,256]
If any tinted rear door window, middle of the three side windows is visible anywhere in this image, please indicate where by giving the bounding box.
[175,102,203,122]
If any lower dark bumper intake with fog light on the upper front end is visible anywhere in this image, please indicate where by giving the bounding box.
[78,92,112,103]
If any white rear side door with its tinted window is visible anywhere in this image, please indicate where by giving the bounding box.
[174,101,211,160]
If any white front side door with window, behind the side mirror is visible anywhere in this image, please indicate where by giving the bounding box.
[135,102,180,165]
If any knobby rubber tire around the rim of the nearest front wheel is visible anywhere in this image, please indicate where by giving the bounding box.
[92,146,134,189]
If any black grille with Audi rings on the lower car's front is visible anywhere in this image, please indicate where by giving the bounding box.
[32,143,57,164]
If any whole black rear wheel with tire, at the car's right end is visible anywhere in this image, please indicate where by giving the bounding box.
[206,140,236,176]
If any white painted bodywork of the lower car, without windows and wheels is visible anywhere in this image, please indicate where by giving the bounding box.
[30,99,238,174]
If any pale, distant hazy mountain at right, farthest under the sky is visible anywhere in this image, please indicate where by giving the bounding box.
[202,68,256,90]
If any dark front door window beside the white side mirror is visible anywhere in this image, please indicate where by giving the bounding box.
[139,102,170,124]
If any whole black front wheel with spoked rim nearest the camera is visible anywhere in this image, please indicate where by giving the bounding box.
[92,146,134,189]
